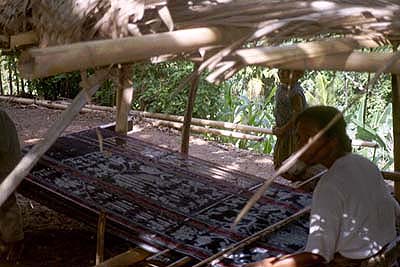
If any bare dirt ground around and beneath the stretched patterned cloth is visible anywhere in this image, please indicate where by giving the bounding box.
[0,102,273,267]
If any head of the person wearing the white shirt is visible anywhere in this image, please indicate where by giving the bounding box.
[295,106,352,167]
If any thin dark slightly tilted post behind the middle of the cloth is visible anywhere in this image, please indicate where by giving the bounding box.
[181,64,199,155]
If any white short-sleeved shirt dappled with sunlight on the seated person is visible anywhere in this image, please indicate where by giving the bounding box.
[305,154,400,262]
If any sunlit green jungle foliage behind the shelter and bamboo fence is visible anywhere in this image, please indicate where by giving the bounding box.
[0,51,393,170]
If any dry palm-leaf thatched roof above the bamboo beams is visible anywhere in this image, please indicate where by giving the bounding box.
[0,0,400,78]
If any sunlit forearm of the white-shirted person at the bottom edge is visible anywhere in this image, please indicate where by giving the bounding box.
[246,252,324,267]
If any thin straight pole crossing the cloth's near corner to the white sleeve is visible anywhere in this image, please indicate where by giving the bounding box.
[193,207,311,267]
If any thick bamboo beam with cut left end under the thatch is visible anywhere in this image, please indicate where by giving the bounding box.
[19,27,247,79]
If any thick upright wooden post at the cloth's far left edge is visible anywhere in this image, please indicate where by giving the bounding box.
[115,66,133,135]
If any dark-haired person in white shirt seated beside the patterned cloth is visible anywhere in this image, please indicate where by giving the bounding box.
[247,106,400,267]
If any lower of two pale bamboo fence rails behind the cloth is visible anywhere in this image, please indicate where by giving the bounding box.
[150,119,264,141]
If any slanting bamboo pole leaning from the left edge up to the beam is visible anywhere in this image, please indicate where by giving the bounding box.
[0,71,106,206]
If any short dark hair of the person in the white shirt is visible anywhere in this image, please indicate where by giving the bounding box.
[295,106,352,152]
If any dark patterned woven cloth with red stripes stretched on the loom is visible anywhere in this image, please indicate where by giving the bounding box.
[26,129,311,262]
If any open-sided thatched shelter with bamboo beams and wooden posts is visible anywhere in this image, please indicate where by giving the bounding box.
[0,0,400,266]
